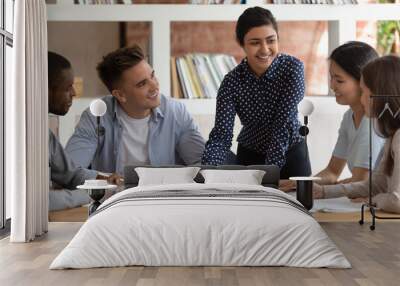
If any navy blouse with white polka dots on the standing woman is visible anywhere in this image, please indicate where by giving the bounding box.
[202,54,305,167]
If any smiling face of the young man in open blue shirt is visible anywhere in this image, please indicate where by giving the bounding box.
[113,60,160,119]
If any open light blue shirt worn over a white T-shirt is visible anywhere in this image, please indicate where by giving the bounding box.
[66,95,205,175]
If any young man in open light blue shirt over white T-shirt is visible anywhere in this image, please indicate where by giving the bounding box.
[65,45,205,175]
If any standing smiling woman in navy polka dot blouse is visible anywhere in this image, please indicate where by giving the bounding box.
[203,7,311,178]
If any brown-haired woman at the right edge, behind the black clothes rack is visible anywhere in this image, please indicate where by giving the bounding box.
[314,56,400,213]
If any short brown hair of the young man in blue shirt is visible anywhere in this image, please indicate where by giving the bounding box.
[97,45,144,92]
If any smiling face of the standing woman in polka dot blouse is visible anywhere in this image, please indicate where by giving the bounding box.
[243,25,278,76]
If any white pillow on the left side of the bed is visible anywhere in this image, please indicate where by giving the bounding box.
[135,167,200,186]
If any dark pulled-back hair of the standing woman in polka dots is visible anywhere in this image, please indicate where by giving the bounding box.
[236,7,278,46]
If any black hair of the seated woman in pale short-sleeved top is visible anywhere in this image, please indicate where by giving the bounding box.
[329,41,379,81]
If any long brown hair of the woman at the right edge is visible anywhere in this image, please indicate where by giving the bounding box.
[362,55,400,176]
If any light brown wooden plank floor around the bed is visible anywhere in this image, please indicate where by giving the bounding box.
[0,222,400,286]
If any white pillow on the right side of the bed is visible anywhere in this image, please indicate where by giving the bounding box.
[200,170,265,185]
